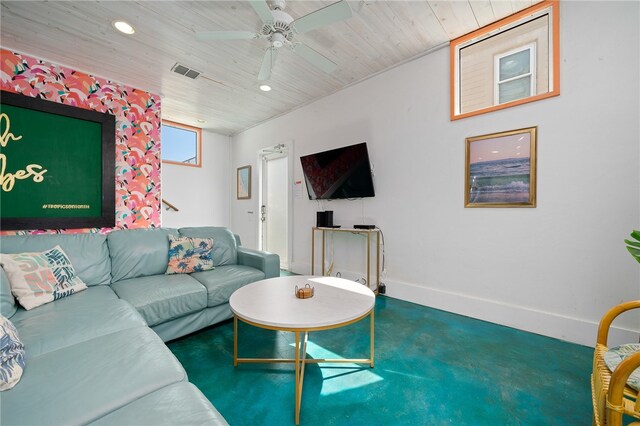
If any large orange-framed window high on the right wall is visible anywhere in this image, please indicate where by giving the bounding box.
[450,1,560,120]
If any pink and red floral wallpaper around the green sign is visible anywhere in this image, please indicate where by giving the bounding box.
[0,49,161,235]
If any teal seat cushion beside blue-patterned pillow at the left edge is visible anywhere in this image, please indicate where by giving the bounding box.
[0,327,186,425]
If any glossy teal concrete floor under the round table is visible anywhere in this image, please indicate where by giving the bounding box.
[168,296,592,426]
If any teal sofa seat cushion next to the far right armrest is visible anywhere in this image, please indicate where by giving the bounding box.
[191,265,264,307]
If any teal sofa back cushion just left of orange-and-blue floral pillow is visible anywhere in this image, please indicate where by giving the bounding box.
[107,228,178,282]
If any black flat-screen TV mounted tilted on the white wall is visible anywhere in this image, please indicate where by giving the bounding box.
[300,142,375,200]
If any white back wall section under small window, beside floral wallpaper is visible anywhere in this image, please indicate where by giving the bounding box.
[162,130,235,228]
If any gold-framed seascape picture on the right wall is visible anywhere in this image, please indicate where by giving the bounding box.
[464,127,538,207]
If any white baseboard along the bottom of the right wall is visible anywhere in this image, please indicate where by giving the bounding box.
[385,280,639,347]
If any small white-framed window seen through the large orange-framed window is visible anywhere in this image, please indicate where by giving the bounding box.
[493,43,536,105]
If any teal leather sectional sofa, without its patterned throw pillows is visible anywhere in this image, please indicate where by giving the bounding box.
[0,227,279,426]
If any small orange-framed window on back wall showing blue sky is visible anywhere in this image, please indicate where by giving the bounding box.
[162,120,202,167]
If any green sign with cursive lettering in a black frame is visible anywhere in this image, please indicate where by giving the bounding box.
[0,91,115,230]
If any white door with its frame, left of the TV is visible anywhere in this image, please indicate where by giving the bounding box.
[258,143,291,270]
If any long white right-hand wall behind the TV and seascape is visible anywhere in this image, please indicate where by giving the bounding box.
[231,2,640,345]
